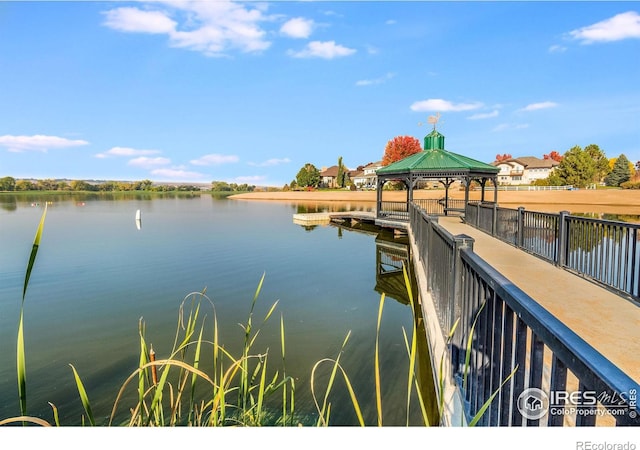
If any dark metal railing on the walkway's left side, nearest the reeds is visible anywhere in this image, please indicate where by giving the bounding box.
[409,204,640,426]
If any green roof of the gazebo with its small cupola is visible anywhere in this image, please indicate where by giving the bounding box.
[376,130,500,175]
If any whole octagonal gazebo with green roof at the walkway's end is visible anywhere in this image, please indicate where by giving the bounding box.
[376,125,500,221]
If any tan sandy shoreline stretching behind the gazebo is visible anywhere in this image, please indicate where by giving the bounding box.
[228,189,640,215]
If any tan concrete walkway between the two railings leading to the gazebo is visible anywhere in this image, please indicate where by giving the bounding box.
[438,217,640,382]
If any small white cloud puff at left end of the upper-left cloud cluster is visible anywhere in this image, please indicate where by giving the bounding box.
[104,7,177,34]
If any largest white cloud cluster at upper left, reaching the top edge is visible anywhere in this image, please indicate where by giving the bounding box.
[104,0,271,56]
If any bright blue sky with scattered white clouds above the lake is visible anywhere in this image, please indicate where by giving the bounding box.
[0,1,640,186]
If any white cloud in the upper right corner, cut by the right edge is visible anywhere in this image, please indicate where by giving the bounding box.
[569,11,640,44]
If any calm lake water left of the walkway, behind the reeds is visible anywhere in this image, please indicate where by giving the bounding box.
[0,194,430,425]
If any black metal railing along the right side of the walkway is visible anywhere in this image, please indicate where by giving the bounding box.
[465,202,640,302]
